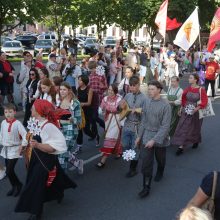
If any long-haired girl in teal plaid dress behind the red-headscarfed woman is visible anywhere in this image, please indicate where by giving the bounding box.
[59,82,83,174]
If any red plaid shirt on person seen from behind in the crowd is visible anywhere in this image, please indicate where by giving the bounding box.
[89,73,108,107]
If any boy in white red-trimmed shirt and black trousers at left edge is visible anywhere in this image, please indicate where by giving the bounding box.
[0,104,27,197]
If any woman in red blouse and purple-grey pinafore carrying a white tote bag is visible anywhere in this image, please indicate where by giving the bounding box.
[172,74,208,156]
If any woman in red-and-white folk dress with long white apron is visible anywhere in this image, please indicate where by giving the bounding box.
[97,84,122,168]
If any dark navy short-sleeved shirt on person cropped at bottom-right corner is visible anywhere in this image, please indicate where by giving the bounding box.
[200,172,220,219]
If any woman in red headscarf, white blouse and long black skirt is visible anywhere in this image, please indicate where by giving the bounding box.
[15,99,76,219]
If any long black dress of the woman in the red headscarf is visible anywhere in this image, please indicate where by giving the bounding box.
[15,136,77,215]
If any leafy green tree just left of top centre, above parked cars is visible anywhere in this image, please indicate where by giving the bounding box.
[79,0,116,42]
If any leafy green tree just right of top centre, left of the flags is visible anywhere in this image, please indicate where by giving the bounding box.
[114,0,144,46]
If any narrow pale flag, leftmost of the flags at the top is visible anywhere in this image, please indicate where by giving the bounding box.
[155,0,168,38]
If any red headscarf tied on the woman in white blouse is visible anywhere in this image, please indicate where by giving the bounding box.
[34,99,70,127]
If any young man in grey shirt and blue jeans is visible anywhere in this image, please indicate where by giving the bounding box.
[121,76,146,177]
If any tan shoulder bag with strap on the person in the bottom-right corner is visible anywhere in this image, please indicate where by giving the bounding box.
[202,171,218,217]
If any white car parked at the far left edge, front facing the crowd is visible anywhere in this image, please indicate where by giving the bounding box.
[2,40,24,57]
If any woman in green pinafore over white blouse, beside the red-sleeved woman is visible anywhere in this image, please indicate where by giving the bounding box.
[167,76,183,137]
